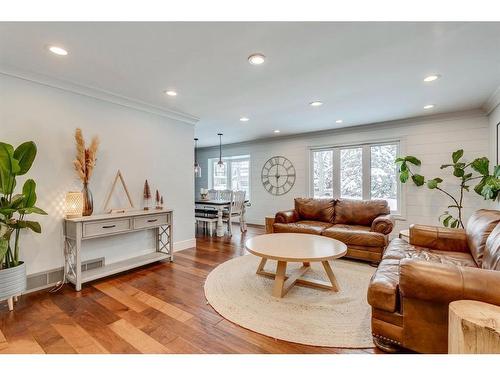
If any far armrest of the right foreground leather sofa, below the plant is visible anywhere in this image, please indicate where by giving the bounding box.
[410,224,469,253]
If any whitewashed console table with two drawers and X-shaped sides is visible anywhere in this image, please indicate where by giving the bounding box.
[64,209,173,291]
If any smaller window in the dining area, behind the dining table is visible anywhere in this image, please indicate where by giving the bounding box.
[208,155,250,199]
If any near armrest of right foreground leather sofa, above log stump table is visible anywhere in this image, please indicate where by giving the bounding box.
[399,259,500,308]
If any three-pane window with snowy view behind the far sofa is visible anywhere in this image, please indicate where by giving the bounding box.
[311,142,400,213]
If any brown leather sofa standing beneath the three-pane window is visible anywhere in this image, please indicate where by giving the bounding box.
[267,198,394,263]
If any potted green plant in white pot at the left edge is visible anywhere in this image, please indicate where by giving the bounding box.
[0,142,47,310]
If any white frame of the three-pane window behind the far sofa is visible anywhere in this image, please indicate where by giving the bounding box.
[308,139,406,220]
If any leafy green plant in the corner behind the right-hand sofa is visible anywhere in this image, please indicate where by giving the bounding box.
[395,149,500,228]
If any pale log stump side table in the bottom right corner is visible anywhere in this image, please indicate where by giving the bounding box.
[448,300,500,354]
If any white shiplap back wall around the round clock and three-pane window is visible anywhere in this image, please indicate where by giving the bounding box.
[195,111,490,235]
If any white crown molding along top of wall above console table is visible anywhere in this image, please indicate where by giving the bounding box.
[0,66,199,125]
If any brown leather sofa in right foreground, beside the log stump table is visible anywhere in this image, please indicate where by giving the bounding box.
[368,210,500,353]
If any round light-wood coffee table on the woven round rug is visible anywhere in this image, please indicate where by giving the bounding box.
[245,233,347,298]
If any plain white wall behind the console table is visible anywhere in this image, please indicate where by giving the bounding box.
[0,74,194,274]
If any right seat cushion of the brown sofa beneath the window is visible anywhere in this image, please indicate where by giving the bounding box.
[323,224,387,247]
